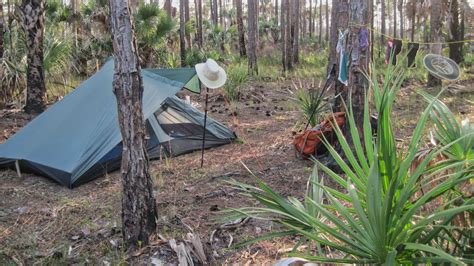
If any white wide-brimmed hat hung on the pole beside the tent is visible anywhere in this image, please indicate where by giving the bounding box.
[195,59,227,89]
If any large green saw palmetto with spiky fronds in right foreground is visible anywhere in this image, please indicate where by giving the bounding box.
[228,60,474,265]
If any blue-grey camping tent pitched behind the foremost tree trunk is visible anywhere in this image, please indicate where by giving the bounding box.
[0,60,236,188]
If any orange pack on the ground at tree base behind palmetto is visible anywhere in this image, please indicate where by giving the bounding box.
[293,112,346,158]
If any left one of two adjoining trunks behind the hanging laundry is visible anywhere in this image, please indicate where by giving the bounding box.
[328,0,349,112]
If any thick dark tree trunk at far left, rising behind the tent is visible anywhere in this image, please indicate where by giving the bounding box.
[21,0,46,114]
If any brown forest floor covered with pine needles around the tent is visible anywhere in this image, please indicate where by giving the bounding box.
[0,76,474,265]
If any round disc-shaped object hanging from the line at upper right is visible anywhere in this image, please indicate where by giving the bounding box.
[423,54,461,80]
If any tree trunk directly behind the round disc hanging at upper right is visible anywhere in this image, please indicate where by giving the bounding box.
[428,0,442,87]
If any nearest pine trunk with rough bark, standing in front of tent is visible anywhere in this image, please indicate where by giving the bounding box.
[109,0,158,251]
